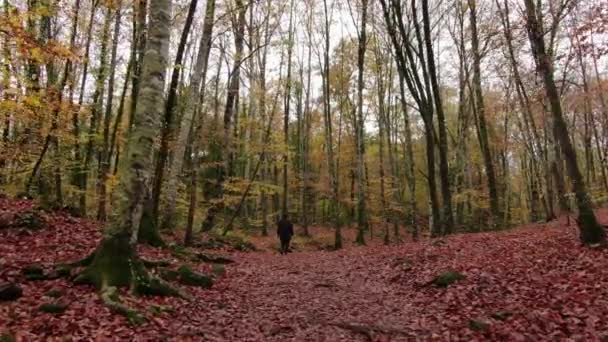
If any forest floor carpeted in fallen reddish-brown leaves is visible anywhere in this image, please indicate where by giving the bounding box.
[0,200,608,341]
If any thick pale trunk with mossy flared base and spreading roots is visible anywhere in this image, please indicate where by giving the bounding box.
[79,0,175,300]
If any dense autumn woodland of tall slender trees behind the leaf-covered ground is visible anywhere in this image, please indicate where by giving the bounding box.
[0,0,608,249]
